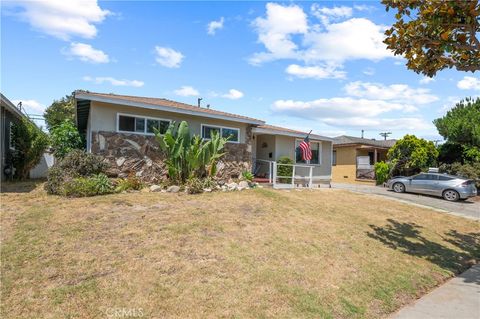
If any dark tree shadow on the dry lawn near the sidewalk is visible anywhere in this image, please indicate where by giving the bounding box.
[367,219,480,284]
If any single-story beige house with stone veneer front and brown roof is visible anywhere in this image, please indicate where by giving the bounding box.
[75,90,332,182]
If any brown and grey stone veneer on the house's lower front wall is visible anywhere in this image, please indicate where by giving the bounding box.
[91,126,252,184]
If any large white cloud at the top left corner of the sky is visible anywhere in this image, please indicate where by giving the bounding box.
[10,0,110,40]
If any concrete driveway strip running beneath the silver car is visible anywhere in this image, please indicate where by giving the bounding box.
[332,183,480,220]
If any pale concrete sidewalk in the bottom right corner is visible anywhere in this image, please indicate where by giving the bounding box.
[391,264,480,319]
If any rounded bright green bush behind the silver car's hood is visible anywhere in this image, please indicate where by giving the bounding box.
[387,134,438,175]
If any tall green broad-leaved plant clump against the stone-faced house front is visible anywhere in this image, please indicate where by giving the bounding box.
[155,121,227,183]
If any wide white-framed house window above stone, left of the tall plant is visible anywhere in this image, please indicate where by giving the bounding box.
[117,114,170,135]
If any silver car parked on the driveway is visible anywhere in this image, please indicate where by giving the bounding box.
[387,173,477,201]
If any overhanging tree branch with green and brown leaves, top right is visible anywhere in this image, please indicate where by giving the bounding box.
[382,0,480,77]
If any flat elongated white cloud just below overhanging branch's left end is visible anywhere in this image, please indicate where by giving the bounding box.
[345,81,438,104]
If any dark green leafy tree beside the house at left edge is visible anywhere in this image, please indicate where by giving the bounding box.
[12,118,48,179]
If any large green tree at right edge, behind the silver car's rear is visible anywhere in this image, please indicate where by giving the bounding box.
[433,98,480,163]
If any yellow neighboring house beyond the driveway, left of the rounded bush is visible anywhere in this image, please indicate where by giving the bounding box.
[332,135,396,184]
